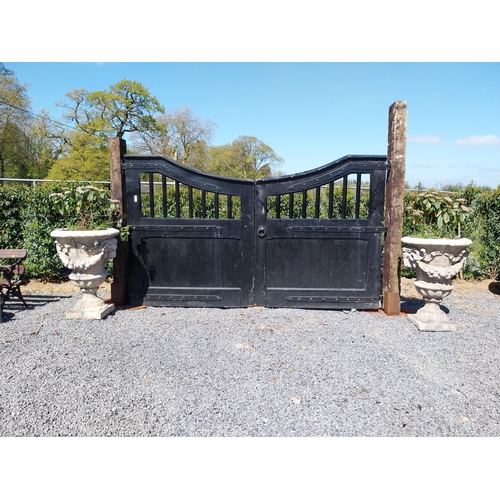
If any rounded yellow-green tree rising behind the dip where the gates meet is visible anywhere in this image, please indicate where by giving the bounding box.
[207,135,284,179]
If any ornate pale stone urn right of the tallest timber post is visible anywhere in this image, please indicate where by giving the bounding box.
[401,236,472,332]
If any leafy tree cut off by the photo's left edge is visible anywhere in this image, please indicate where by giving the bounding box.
[0,63,31,177]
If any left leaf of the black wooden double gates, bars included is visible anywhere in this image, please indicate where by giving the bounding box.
[124,155,254,307]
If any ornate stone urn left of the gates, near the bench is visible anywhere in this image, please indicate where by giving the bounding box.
[50,229,120,319]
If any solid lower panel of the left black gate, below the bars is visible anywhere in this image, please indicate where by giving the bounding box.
[131,221,243,307]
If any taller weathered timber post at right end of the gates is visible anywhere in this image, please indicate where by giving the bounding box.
[383,101,407,316]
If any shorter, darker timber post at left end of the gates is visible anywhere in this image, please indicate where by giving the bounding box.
[108,137,128,306]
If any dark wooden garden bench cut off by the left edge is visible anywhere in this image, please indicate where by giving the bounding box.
[0,249,28,323]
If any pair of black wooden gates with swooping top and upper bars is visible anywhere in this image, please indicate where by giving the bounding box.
[123,155,388,309]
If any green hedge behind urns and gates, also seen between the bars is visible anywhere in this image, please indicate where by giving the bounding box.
[0,182,500,281]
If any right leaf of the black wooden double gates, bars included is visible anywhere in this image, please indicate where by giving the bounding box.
[255,157,387,309]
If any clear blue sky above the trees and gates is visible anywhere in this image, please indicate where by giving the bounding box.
[5,62,500,187]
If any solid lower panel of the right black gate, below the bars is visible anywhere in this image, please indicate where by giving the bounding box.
[266,229,380,309]
